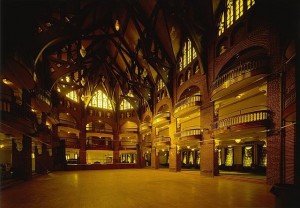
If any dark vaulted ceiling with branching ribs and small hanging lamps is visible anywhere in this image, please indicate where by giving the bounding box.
[1,0,220,110]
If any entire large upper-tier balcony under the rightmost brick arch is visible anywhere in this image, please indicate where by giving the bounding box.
[210,58,269,100]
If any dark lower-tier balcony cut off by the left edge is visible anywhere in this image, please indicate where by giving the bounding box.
[0,97,37,134]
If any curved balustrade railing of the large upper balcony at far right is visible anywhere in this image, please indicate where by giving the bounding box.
[210,59,268,91]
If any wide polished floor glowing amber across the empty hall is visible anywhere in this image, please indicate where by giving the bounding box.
[0,169,275,208]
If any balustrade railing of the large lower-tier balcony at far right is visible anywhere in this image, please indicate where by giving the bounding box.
[212,110,271,129]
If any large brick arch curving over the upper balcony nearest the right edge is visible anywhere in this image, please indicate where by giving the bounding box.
[215,29,270,74]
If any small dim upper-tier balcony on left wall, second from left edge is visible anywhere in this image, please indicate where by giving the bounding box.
[31,88,52,113]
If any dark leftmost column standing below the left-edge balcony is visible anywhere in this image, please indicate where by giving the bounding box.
[12,135,32,180]
